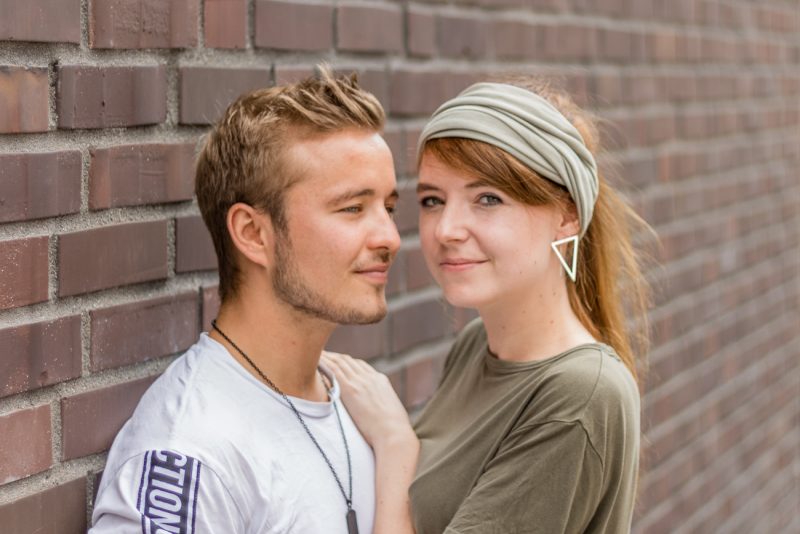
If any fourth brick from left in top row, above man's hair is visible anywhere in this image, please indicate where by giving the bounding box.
[255,0,333,51]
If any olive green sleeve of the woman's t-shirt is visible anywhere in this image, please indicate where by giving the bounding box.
[445,422,603,534]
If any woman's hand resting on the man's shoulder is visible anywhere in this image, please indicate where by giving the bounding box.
[320,352,417,450]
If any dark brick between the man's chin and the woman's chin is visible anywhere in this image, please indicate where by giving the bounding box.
[389,300,447,353]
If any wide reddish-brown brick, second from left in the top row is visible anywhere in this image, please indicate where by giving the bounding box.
[89,0,200,48]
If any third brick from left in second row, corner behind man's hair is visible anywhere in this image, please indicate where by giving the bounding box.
[180,67,272,124]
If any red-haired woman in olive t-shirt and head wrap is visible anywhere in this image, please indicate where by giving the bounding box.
[325,77,648,534]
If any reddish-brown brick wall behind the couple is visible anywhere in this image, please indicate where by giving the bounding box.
[0,0,800,534]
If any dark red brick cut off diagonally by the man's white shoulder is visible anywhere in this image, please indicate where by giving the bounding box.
[61,376,156,460]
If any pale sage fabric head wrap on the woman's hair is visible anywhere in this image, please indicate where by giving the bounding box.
[417,83,598,237]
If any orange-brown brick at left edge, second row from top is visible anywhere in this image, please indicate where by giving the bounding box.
[0,66,50,134]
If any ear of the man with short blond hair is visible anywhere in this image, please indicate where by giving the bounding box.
[226,202,275,268]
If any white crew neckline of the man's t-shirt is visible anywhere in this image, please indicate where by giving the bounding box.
[200,332,340,418]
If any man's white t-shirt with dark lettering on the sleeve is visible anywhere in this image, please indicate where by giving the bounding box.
[89,333,375,534]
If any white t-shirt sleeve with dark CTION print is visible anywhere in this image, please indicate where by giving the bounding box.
[89,450,245,534]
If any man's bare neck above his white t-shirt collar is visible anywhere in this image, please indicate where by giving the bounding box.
[209,292,336,401]
